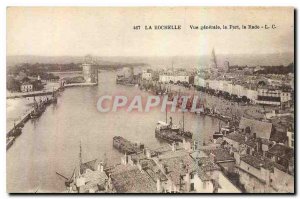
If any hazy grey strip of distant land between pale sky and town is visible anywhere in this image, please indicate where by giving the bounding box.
[6,52,295,68]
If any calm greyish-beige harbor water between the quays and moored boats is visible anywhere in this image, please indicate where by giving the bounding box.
[6,71,219,192]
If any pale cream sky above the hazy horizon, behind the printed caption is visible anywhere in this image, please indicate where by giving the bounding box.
[7,7,294,56]
